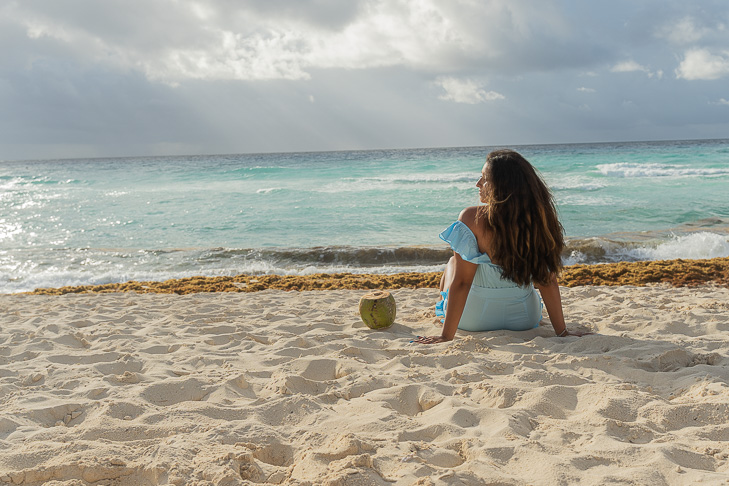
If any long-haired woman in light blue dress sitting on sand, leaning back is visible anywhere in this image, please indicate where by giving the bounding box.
[415,150,586,344]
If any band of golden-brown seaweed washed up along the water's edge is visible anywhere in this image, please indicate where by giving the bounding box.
[21,257,729,295]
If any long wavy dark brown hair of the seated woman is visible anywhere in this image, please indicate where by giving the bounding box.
[479,150,564,286]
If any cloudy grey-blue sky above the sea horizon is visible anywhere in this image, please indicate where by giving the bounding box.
[0,0,729,160]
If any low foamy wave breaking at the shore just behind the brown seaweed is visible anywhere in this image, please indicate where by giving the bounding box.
[5,231,729,293]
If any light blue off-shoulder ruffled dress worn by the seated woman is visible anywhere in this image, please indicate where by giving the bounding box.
[436,221,542,331]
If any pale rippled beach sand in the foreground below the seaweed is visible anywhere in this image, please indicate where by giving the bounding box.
[0,287,729,486]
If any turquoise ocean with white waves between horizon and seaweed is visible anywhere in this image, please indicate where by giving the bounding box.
[0,140,729,293]
